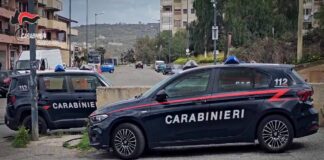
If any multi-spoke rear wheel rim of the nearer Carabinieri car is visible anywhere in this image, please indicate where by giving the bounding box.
[262,120,289,149]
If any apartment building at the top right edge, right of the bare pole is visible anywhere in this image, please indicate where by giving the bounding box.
[303,0,324,34]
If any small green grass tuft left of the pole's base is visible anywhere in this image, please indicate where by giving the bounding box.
[12,127,30,148]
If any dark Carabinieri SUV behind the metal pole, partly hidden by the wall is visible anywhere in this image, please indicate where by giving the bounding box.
[5,67,111,134]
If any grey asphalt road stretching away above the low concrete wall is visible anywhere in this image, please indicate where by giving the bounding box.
[103,65,167,86]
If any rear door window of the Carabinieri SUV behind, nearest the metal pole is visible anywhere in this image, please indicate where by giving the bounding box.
[41,76,67,92]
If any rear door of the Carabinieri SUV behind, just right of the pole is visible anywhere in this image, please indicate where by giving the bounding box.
[38,74,75,123]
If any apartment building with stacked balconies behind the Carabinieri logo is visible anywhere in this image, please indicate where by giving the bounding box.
[0,0,78,69]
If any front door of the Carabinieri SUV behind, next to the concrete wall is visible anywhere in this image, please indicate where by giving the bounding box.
[68,74,102,118]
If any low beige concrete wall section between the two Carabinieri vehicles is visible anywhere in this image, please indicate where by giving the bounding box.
[97,86,150,108]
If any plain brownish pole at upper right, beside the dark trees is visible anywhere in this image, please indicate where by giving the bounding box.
[297,0,304,62]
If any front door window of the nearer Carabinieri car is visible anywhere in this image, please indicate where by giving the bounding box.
[165,71,211,98]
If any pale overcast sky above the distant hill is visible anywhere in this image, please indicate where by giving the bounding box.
[59,0,160,25]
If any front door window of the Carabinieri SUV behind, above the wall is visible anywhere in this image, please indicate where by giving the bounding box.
[71,76,101,92]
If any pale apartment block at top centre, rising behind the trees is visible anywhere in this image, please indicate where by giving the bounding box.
[160,0,197,34]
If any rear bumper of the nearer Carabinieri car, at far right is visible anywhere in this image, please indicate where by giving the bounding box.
[295,108,319,138]
